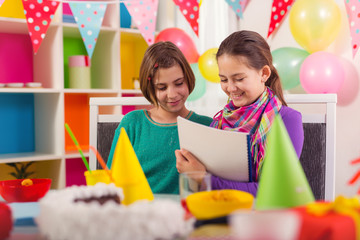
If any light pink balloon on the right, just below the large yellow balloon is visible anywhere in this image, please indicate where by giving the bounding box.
[300,51,345,93]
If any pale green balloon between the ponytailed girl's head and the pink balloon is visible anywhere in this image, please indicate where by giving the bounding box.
[272,47,310,90]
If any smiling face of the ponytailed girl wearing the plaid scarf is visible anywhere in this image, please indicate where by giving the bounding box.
[218,54,271,107]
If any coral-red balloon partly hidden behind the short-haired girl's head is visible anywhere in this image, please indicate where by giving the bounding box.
[155,28,199,64]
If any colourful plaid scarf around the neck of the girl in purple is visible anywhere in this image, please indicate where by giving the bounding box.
[211,87,281,181]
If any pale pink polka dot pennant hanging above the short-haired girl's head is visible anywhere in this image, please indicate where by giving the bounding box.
[125,0,159,45]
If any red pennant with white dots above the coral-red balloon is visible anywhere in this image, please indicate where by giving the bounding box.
[173,0,199,36]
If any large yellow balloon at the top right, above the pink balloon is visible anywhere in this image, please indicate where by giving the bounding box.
[289,0,341,53]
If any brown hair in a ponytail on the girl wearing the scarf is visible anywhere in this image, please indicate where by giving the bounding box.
[216,30,287,106]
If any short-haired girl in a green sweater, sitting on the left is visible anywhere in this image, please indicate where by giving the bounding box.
[107,42,212,194]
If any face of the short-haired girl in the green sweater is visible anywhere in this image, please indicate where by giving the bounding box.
[154,64,189,114]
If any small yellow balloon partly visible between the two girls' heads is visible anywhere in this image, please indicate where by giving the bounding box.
[198,48,220,83]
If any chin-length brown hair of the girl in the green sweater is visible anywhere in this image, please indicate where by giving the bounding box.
[139,41,195,106]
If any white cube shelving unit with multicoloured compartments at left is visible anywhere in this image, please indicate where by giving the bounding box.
[0,0,167,188]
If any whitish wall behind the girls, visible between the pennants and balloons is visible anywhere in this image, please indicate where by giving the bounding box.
[158,0,360,196]
